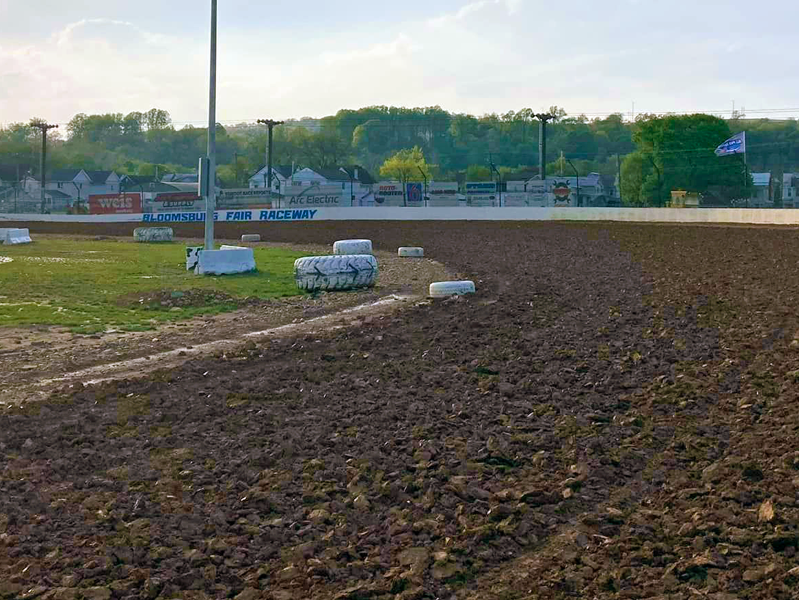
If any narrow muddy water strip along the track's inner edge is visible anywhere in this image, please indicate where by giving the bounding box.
[36,295,417,387]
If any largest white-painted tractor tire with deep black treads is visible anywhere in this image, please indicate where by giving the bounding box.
[294,254,377,292]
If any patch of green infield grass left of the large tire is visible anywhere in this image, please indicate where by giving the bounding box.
[0,239,302,333]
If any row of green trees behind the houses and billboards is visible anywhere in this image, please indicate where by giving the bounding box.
[0,106,799,205]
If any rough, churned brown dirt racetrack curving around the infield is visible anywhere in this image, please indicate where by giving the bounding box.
[0,222,799,600]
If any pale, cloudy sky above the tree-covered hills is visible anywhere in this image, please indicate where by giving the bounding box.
[0,0,799,125]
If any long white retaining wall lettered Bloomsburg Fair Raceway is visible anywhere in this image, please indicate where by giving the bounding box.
[7,207,799,225]
